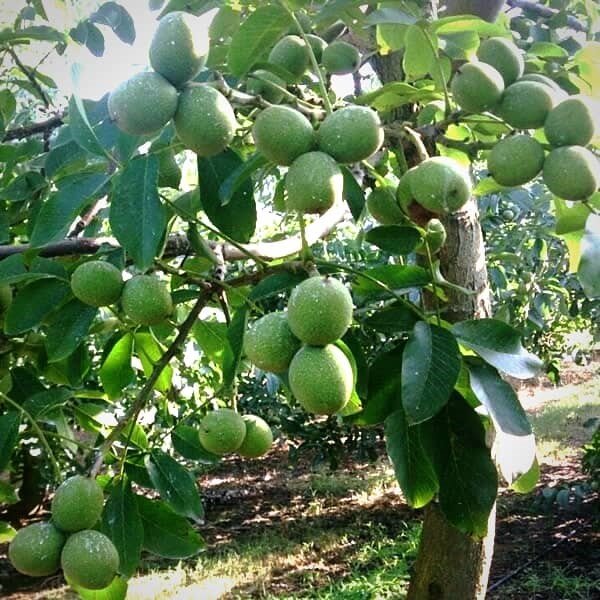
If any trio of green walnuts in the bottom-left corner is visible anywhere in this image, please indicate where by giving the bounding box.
[8,475,119,590]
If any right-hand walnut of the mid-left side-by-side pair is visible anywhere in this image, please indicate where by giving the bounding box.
[121,275,173,325]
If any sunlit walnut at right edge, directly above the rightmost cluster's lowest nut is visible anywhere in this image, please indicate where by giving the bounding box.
[544,96,600,146]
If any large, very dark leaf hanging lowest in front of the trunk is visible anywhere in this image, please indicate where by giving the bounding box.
[432,394,498,537]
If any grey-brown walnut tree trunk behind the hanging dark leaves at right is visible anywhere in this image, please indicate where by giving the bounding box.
[407,199,496,600]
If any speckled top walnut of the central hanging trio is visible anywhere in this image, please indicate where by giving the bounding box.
[288,277,353,346]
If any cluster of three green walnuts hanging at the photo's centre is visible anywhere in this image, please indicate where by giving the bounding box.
[244,277,353,415]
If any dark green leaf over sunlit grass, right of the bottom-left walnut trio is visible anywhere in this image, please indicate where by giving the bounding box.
[136,496,204,559]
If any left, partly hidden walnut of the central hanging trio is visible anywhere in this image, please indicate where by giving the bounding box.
[244,311,300,373]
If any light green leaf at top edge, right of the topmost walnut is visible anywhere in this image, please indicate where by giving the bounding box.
[227,4,292,77]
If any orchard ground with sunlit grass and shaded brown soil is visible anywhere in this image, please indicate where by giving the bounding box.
[0,359,600,600]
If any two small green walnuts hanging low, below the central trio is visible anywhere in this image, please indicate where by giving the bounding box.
[198,408,273,458]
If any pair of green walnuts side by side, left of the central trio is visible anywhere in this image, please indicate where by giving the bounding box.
[71,260,173,325]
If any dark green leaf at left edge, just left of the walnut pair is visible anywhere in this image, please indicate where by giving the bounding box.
[4,279,71,335]
